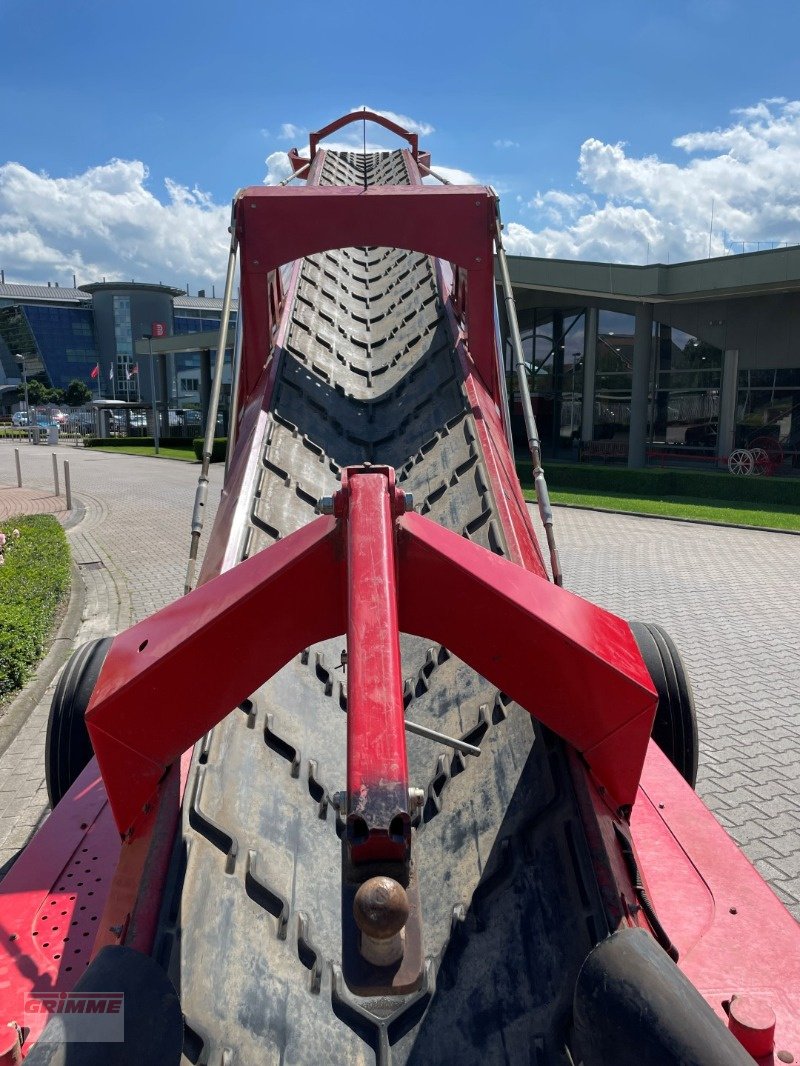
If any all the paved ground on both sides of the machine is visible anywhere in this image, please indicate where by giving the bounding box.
[0,442,800,917]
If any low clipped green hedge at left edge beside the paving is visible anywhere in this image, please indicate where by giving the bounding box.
[0,515,70,700]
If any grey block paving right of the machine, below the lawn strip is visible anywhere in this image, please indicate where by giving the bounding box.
[533,507,800,918]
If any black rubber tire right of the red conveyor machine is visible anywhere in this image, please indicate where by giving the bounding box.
[630,621,699,788]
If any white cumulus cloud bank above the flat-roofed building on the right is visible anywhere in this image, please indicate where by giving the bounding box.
[506,98,800,262]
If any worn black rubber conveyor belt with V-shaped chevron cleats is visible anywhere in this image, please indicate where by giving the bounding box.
[156,151,607,1066]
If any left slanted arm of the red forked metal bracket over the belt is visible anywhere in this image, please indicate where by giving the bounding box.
[86,518,346,834]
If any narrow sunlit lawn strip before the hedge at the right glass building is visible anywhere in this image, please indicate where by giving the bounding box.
[525,489,800,530]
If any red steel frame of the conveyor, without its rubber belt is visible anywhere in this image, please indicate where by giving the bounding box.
[0,112,800,1066]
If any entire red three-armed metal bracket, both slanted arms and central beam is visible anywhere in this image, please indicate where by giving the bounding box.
[86,468,656,834]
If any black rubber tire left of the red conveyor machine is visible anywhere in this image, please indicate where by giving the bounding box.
[45,636,112,807]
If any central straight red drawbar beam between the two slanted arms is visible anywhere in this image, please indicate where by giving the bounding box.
[334,467,411,862]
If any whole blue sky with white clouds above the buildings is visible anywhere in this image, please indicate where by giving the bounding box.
[0,0,800,287]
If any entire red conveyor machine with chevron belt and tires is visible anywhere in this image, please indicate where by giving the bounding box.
[0,112,800,1066]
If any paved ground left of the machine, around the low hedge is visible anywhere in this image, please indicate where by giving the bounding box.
[0,441,222,869]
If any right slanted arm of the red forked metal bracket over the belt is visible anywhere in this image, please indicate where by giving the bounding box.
[398,514,657,808]
